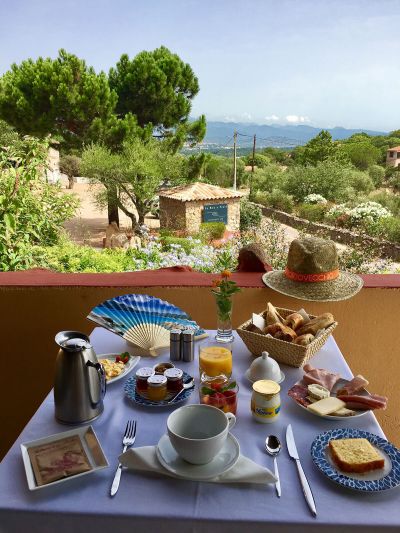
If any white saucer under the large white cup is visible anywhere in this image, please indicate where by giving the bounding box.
[156,433,240,481]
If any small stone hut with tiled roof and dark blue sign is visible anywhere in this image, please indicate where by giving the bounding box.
[159,182,243,233]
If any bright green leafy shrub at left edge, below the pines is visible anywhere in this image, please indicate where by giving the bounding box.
[0,137,78,271]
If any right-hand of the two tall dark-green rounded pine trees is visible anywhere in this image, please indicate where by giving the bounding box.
[109,46,206,151]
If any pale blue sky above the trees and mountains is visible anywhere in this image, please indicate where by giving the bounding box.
[0,0,400,131]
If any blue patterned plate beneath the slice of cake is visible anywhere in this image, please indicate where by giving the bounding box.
[311,428,400,492]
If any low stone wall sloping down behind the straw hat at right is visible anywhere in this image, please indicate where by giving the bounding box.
[254,204,400,261]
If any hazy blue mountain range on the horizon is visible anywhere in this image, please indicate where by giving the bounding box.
[203,121,387,148]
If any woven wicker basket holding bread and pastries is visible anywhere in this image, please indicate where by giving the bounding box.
[236,307,338,367]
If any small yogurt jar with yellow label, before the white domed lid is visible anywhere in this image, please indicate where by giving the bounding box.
[251,379,281,424]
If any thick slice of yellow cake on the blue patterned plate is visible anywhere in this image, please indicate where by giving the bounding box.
[329,439,385,473]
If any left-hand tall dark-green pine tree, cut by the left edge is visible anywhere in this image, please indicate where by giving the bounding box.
[0,50,117,149]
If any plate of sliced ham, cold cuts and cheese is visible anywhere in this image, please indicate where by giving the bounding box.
[288,364,387,420]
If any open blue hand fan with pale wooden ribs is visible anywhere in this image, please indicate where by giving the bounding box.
[87,294,207,357]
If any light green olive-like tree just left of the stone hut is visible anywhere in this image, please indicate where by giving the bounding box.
[82,138,183,232]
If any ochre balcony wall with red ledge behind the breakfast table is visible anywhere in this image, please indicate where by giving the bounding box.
[0,270,400,457]
